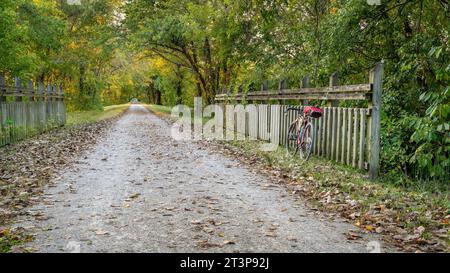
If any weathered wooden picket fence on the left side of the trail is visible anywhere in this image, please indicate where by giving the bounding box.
[0,76,66,147]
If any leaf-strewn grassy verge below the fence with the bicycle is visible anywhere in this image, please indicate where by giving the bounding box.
[211,141,450,252]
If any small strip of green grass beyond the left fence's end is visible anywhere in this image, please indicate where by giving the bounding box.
[67,104,130,126]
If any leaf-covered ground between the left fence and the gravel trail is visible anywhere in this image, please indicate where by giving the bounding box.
[0,113,124,252]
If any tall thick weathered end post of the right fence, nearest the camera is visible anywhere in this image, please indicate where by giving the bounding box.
[369,61,384,180]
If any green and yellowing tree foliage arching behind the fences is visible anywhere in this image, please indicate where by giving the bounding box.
[0,0,450,182]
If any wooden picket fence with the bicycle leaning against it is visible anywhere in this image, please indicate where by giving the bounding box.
[215,62,383,179]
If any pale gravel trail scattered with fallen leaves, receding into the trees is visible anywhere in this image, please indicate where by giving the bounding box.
[18,105,384,252]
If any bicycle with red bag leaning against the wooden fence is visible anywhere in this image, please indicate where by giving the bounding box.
[284,106,322,160]
